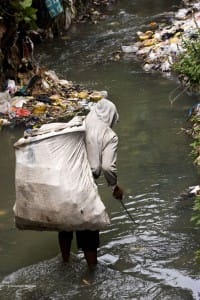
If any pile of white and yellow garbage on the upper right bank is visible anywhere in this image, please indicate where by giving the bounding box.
[122,1,200,75]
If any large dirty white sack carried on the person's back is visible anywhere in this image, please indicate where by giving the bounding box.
[13,118,110,231]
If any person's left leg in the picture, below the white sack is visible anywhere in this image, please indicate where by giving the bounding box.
[58,231,73,263]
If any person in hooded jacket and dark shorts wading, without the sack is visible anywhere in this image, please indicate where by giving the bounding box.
[58,99,123,268]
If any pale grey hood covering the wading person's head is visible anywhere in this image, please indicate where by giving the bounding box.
[94,98,119,127]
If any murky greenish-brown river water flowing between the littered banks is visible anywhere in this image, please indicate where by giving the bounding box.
[0,0,200,300]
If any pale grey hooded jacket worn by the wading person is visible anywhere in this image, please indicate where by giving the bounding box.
[85,99,119,186]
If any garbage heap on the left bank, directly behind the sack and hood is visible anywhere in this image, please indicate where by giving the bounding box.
[0,70,107,128]
